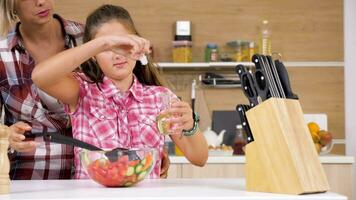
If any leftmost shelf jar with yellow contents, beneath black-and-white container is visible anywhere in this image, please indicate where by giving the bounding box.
[173,40,192,63]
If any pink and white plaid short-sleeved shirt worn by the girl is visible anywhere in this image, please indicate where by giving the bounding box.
[67,74,175,179]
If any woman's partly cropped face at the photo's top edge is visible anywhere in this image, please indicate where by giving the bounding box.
[14,0,54,25]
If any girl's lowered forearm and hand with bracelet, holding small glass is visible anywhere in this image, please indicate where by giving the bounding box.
[167,101,208,166]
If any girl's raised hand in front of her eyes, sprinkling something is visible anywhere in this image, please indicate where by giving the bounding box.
[101,35,150,60]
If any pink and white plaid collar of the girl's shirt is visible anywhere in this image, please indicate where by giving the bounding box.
[99,75,143,102]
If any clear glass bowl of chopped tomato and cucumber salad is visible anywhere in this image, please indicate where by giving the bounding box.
[80,148,156,187]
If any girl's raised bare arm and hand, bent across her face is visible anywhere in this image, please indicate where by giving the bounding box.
[32,36,148,108]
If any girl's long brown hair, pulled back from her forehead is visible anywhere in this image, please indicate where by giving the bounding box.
[81,5,166,86]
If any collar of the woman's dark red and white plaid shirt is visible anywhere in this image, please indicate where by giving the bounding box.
[7,14,83,52]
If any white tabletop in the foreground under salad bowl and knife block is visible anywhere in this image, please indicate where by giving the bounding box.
[0,179,347,200]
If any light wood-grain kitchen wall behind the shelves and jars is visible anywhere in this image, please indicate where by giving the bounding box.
[56,0,345,154]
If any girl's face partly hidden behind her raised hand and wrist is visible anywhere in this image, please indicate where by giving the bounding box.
[94,20,136,81]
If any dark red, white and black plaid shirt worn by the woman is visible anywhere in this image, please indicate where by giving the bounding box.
[0,15,83,179]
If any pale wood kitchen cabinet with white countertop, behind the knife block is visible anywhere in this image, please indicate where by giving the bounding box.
[168,155,355,199]
